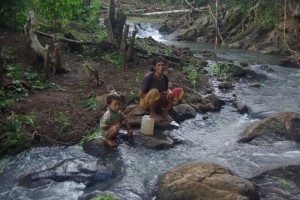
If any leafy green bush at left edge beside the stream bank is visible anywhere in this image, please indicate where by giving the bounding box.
[0,113,35,155]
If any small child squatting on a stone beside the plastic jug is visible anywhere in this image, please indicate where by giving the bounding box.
[100,94,133,147]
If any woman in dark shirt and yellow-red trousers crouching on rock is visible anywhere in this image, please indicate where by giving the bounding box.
[139,57,184,122]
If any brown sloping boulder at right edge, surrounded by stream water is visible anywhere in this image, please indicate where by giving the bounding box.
[239,112,300,142]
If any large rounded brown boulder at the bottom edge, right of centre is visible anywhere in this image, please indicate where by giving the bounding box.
[156,163,259,200]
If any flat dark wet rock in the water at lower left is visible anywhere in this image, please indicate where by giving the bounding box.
[19,159,113,188]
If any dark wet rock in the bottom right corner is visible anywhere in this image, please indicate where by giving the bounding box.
[250,165,300,200]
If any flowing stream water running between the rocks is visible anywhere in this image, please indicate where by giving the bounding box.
[0,23,300,200]
